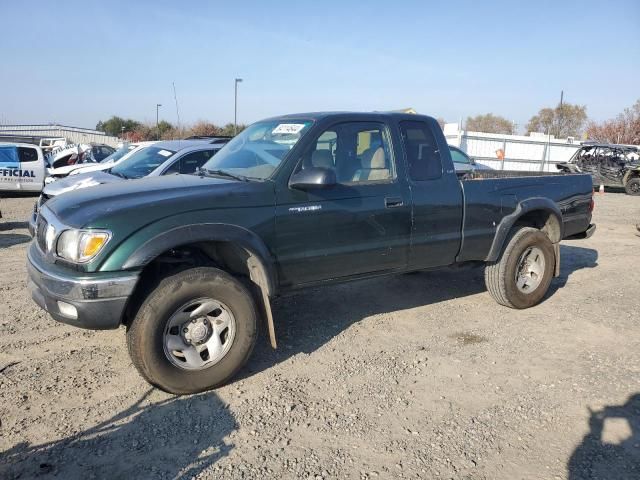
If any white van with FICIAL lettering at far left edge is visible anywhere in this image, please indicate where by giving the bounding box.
[0,143,45,192]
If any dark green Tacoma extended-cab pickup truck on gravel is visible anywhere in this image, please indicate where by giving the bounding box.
[28,113,595,394]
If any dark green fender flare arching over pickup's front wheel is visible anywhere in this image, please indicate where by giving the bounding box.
[122,223,277,296]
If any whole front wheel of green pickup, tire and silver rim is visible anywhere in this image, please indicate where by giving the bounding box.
[127,267,257,394]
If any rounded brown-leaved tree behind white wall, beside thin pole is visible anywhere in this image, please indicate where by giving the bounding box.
[527,103,587,138]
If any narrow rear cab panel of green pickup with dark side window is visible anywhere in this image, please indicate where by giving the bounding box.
[400,120,463,269]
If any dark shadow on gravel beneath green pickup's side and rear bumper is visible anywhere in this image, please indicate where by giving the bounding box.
[242,245,598,379]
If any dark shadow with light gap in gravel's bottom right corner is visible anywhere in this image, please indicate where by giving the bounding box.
[567,393,640,480]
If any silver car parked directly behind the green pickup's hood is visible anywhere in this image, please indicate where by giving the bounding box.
[32,140,228,216]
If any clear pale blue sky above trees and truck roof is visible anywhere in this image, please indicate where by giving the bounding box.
[0,0,640,129]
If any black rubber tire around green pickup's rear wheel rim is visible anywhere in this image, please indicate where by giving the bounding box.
[484,227,555,309]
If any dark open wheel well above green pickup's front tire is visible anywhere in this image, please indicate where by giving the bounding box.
[122,241,270,325]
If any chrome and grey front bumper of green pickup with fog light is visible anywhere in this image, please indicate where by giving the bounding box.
[27,242,138,330]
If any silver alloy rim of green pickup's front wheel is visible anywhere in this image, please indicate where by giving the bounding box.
[162,298,236,370]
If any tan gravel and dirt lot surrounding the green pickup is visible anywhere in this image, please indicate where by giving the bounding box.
[0,193,640,479]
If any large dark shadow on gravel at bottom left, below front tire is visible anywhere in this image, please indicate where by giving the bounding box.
[0,389,238,479]
